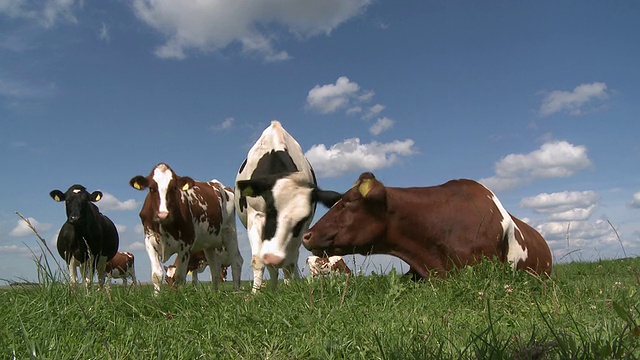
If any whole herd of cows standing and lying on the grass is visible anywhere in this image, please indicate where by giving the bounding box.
[50,121,552,294]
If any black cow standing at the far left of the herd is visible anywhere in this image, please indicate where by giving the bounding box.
[49,184,120,287]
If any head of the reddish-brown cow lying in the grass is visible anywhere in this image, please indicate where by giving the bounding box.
[302,172,387,256]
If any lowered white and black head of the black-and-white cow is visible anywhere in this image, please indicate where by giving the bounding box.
[236,172,341,266]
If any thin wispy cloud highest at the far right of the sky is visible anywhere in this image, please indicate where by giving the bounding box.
[540,82,609,116]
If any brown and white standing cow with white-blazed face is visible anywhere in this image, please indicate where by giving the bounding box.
[129,163,243,295]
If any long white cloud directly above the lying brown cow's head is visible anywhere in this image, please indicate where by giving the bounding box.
[305,138,417,177]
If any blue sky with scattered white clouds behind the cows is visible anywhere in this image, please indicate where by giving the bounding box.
[0,0,640,281]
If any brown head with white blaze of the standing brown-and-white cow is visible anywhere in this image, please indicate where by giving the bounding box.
[129,163,194,222]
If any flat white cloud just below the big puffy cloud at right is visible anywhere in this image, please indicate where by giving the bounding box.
[520,191,600,221]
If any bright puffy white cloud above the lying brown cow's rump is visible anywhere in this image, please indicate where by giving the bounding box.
[480,141,591,191]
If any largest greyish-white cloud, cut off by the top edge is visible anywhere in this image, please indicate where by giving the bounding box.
[133,0,371,61]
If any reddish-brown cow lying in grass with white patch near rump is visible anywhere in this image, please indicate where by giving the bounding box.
[303,172,552,278]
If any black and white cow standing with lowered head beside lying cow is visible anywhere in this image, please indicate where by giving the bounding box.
[235,120,340,293]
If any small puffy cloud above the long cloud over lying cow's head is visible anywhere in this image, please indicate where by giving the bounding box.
[307,76,362,114]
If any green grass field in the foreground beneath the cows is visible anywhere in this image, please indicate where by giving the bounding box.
[0,258,640,359]
